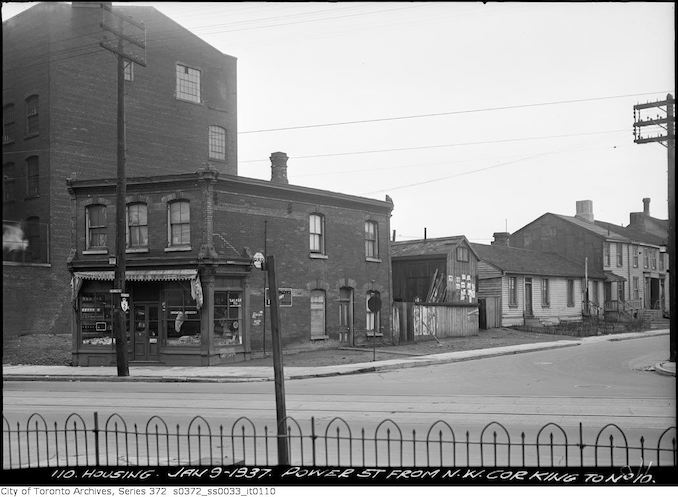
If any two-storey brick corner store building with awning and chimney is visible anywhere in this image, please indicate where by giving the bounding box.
[68,157,393,366]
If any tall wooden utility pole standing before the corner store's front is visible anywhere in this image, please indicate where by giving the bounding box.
[99,4,146,376]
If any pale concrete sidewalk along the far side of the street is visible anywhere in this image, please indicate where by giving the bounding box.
[2,330,676,383]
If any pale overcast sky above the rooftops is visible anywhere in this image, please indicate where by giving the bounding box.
[2,2,675,243]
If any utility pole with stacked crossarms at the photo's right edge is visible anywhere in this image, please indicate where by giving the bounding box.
[633,93,678,362]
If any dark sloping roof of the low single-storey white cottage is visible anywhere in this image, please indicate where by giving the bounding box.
[471,243,604,279]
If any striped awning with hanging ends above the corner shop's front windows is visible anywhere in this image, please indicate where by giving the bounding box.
[71,269,203,309]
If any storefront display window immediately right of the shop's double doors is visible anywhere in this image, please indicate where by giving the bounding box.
[163,283,200,346]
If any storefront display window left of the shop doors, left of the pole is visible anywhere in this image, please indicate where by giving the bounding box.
[79,292,113,346]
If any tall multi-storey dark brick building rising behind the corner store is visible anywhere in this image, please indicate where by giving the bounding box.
[2,2,237,335]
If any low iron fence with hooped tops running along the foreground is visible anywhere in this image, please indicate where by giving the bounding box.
[3,412,678,469]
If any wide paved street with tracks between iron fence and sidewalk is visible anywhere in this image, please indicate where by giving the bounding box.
[3,336,676,464]
